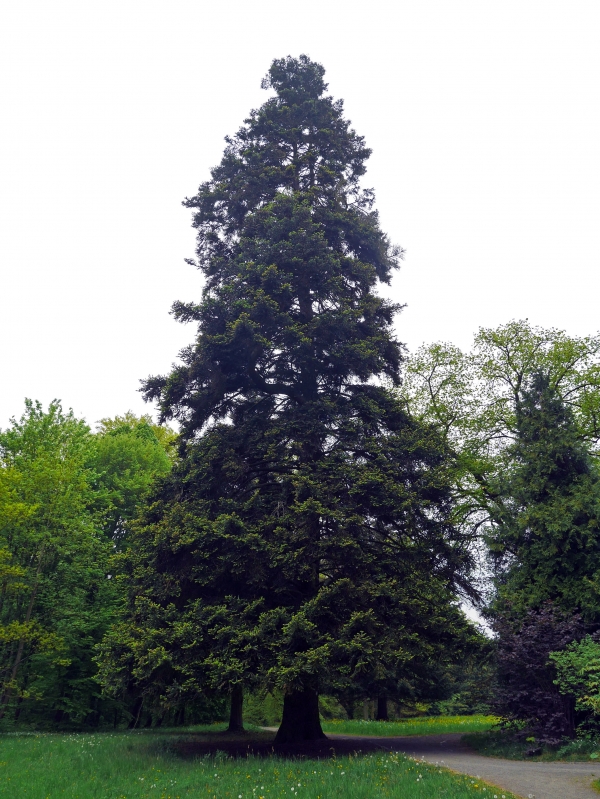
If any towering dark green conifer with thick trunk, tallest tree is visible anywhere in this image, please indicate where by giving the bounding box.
[101,56,473,741]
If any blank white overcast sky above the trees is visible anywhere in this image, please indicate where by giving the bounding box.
[0,0,600,427]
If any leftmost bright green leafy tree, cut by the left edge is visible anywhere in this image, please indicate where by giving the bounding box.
[0,401,113,716]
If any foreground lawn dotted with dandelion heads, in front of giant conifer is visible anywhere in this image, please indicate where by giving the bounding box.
[0,732,514,799]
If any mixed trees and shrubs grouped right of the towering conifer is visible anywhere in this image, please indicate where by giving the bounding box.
[402,320,600,743]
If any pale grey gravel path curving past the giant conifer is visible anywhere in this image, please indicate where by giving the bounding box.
[328,733,600,799]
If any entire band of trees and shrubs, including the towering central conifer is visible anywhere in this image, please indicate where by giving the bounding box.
[0,56,600,742]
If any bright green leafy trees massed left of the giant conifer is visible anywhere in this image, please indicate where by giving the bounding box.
[0,400,174,724]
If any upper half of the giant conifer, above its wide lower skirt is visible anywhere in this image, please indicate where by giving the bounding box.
[144,55,401,435]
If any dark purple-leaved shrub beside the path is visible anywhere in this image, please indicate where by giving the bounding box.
[492,602,585,744]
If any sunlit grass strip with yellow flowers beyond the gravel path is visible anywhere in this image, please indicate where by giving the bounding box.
[323,716,498,736]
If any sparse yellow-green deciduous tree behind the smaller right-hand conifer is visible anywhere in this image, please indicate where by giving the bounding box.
[401,320,600,600]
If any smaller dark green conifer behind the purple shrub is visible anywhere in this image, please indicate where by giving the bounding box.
[490,373,600,621]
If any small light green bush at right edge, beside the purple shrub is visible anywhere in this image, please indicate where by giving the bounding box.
[550,635,600,715]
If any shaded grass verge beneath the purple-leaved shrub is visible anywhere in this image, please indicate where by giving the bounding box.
[464,730,600,762]
